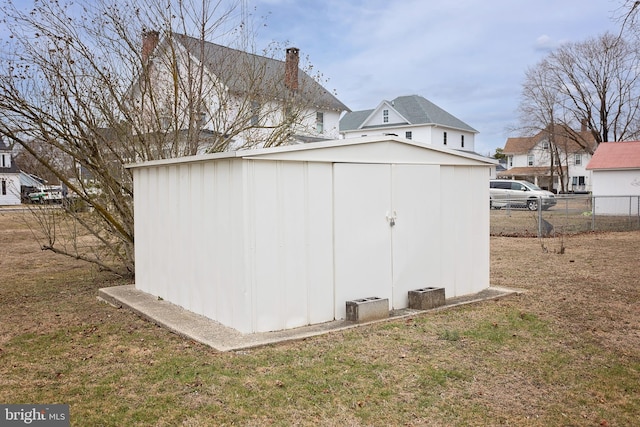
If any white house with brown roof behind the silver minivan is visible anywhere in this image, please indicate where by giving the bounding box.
[497,126,596,193]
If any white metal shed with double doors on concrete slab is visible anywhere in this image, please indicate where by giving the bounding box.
[130,136,493,333]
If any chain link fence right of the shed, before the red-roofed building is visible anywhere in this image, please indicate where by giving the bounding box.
[491,195,640,237]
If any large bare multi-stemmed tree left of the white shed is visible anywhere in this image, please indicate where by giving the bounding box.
[0,0,346,275]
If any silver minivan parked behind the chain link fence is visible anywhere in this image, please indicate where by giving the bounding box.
[489,179,556,211]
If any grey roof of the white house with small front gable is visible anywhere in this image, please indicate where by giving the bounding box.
[340,95,478,133]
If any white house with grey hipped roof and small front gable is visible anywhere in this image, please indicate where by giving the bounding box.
[340,95,478,152]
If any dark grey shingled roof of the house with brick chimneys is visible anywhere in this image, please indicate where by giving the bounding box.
[172,33,351,111]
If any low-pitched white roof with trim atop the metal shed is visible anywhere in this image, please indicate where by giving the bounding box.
[127,135,497,168]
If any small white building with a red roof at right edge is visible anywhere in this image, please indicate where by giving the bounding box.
[587,141,640,215]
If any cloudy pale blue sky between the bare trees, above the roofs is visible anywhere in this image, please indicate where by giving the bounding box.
[247,0,622,154]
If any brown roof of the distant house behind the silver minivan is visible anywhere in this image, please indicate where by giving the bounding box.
[503,125,596,154]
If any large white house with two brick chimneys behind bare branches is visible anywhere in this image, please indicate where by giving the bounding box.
[129,31,349,154]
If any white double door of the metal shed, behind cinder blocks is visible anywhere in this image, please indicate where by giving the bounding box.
[333,163,440,319]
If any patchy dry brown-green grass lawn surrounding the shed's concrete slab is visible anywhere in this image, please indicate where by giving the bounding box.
[0,212,640,426]
